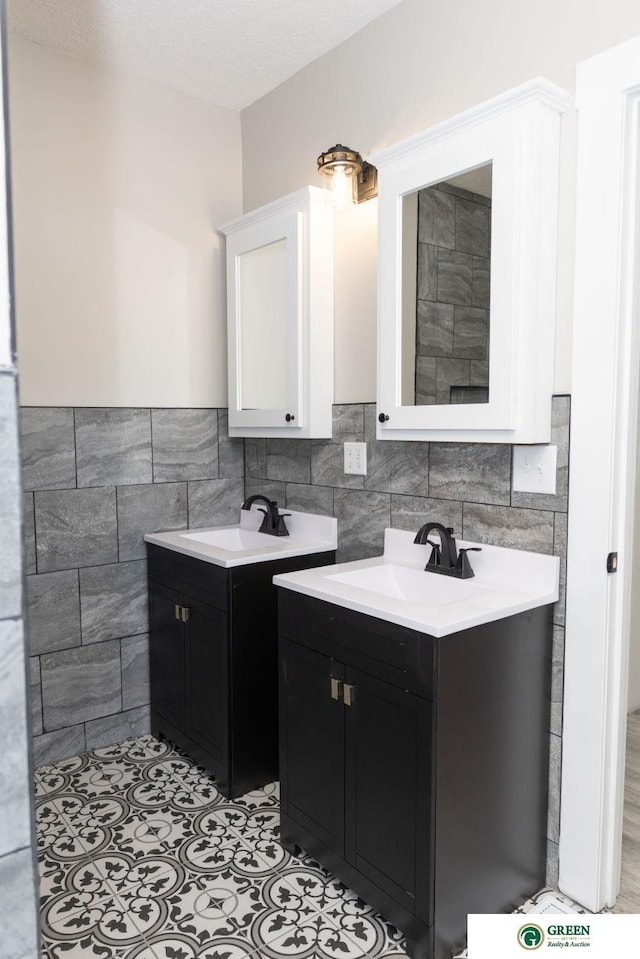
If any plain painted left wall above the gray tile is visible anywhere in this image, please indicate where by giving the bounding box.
[7,35,242,406]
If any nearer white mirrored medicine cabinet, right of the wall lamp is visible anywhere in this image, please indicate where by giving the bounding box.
[371,79,572,443]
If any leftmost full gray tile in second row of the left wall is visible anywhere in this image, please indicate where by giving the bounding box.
[35,486,118,573]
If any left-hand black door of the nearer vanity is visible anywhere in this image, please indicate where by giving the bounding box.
[280,639,344,855]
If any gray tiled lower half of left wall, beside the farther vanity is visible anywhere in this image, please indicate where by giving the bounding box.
[21,407,244,766]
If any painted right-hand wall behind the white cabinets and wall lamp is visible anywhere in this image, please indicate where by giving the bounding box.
[242,0,640,402]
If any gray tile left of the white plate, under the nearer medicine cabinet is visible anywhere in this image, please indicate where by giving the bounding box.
[429,443,511,505]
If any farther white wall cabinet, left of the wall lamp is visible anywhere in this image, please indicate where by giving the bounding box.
[221,187,333,439]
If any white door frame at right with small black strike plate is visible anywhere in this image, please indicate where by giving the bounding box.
[558,37,640,911]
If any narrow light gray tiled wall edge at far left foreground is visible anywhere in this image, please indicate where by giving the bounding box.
[0,370,39,959]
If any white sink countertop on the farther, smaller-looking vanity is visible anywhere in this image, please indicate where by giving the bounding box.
[144,504,338,568]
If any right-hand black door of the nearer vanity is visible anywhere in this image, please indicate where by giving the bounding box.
[344,668,430,912]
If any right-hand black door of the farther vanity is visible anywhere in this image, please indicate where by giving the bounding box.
[185,597,229,765]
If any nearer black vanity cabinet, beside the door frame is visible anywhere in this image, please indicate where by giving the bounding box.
[279,589,551,959]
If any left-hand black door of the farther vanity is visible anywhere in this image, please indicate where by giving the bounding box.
[149,580,184,730]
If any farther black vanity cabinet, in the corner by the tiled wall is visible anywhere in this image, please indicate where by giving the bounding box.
[147,544,335,798]
